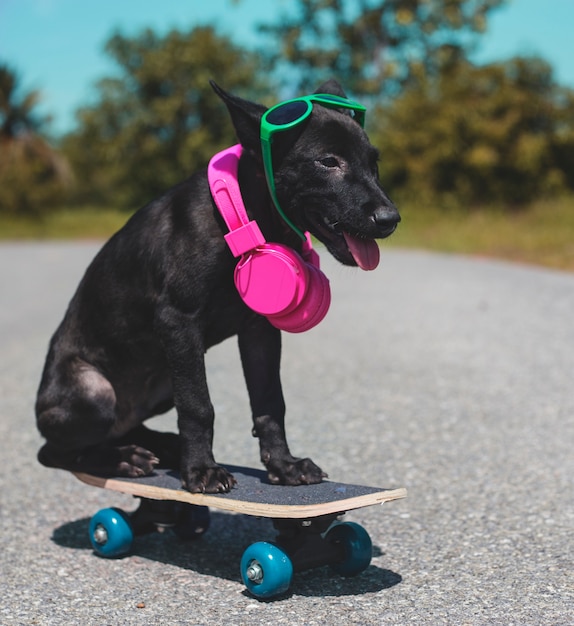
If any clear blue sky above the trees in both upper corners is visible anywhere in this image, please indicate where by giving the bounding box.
[0,0,574,132]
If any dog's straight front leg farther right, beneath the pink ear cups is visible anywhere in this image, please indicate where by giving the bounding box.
[239,318,327,485]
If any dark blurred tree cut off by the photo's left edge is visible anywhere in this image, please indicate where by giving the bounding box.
[0,64,71,215]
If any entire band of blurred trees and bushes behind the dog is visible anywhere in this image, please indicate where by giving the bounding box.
[4,0,574,215]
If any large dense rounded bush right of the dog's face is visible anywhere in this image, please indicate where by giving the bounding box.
[374,58,574,206]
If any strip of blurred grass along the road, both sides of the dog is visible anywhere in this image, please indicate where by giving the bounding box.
[0,197,574,271]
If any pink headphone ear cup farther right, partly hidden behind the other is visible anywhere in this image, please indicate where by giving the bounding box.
[267,263,331,333]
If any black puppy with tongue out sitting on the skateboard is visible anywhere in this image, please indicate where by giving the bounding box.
[36,81,400,493]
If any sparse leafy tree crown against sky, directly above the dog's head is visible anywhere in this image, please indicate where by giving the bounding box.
[260,0,505,97]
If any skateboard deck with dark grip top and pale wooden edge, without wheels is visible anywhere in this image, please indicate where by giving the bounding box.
[75,465,406,519]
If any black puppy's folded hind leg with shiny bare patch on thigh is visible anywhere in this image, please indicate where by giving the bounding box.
[36,358,162,477]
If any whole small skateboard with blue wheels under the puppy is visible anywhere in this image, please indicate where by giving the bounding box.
[74,465,406,598]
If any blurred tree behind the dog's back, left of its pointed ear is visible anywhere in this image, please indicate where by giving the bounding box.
[64,27,272,208]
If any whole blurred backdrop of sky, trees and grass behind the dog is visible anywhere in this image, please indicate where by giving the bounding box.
[0,0,574,270]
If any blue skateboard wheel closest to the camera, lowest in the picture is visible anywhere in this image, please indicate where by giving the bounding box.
[241,541,293,598]
